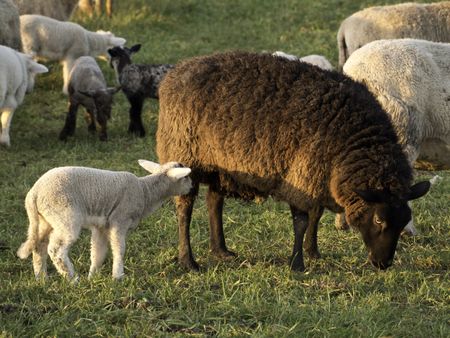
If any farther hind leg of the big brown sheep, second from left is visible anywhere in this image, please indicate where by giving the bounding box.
[206,186,236,258]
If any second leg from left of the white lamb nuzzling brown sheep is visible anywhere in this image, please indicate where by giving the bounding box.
[48,231,78,279]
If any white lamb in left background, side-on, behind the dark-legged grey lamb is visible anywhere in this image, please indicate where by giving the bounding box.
[20,15,126,94]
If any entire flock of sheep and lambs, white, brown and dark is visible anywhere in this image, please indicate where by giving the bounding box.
[0,0,450,278]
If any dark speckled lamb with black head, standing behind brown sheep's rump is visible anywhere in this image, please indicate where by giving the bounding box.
[108,45,173,137]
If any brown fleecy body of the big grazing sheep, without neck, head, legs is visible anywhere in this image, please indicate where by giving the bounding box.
[157,53,396,202]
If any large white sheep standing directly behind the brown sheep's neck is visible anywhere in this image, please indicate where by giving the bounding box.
[336,39,450,235]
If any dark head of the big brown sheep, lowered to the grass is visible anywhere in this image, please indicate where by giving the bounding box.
[346,181,430,270]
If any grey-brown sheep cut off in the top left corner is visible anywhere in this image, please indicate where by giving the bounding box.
[0,0,22,51]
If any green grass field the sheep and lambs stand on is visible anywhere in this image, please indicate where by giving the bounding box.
[0,0,450,337]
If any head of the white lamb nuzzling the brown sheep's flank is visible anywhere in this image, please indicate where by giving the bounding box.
[138,160,192,196]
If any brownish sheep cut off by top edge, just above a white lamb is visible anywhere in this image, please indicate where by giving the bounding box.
[13,0,78,21]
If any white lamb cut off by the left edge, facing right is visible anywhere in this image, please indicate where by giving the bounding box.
[0,46,48,146]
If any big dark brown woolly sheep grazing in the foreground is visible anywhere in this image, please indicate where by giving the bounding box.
[157,52,429,270]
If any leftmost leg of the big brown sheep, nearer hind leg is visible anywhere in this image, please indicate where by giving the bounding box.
[175,184,199,270]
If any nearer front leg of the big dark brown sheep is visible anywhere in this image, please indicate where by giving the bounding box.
[290,205,308,271]
